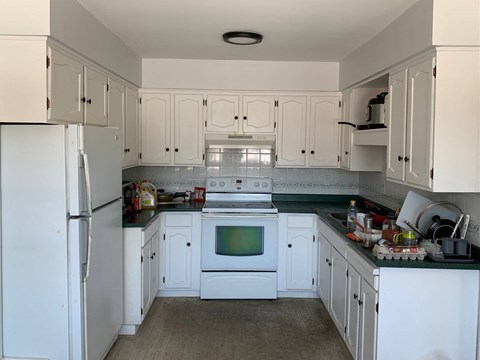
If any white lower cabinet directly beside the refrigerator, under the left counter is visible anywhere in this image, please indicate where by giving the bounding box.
[120,217,160,335]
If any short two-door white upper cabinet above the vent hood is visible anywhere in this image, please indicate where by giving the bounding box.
[206,94,275,134]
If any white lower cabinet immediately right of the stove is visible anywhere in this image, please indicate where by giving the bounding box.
[277,214,317,297]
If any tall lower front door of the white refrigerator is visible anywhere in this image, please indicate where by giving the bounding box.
[83,199,123,360]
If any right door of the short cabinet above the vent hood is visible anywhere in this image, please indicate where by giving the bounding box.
[240,95,275,134]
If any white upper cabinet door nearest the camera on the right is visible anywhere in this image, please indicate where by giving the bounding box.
[405,58,436,188]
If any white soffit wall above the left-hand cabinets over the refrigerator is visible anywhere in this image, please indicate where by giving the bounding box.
[50,0,142,86]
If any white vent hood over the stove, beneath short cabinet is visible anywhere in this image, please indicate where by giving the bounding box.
[205,134,275,149]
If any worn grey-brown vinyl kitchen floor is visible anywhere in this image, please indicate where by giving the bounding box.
[106,298,352,360]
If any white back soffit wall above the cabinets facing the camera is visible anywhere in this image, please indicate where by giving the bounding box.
[142,59,339,91]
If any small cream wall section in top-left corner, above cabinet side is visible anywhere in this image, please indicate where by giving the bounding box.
[0,0,50,35]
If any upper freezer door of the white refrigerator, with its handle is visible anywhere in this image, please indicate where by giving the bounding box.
[68,125,122,215]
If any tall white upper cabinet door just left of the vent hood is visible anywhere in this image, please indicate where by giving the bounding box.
[174,94,204,165]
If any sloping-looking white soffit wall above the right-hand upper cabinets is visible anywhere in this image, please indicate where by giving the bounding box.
[340,0,434,90]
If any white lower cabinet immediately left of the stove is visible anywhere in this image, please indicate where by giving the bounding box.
[159,212,201,296]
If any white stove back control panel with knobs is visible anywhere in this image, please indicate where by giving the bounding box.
[206,177,273,193]
